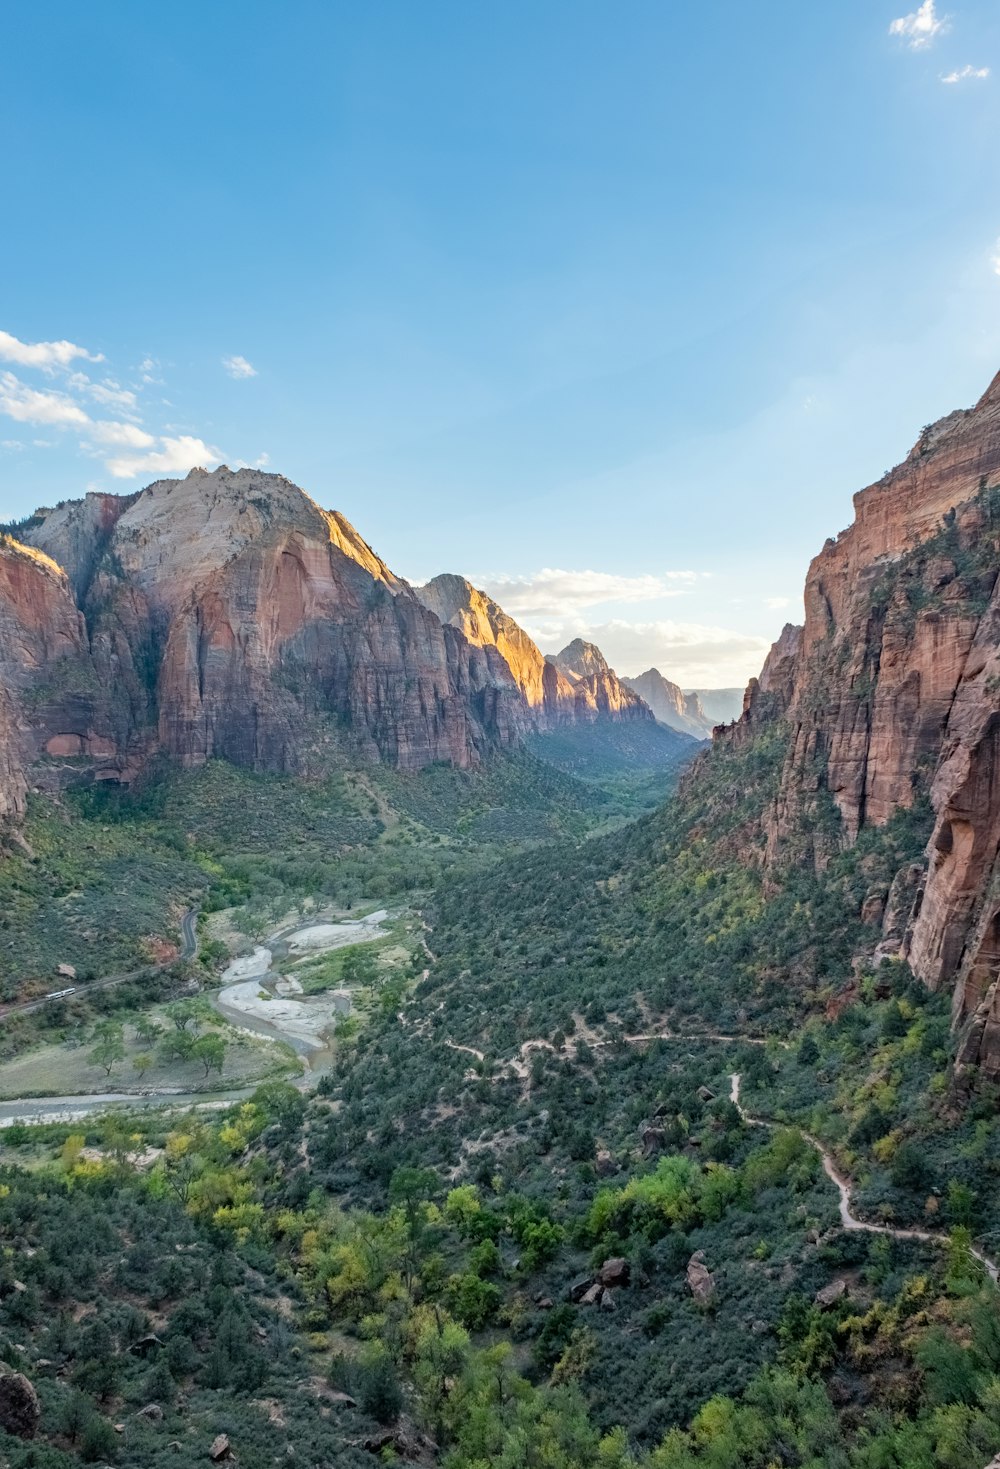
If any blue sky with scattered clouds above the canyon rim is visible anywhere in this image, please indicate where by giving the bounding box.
[0,0,1000,686]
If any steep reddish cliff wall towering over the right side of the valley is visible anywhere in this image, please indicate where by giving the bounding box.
[728,376,1000,1077]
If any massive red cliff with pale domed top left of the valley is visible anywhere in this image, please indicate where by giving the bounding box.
[0,467,530,817]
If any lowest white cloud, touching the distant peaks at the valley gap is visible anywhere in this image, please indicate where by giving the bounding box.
[527,618,771,689]
